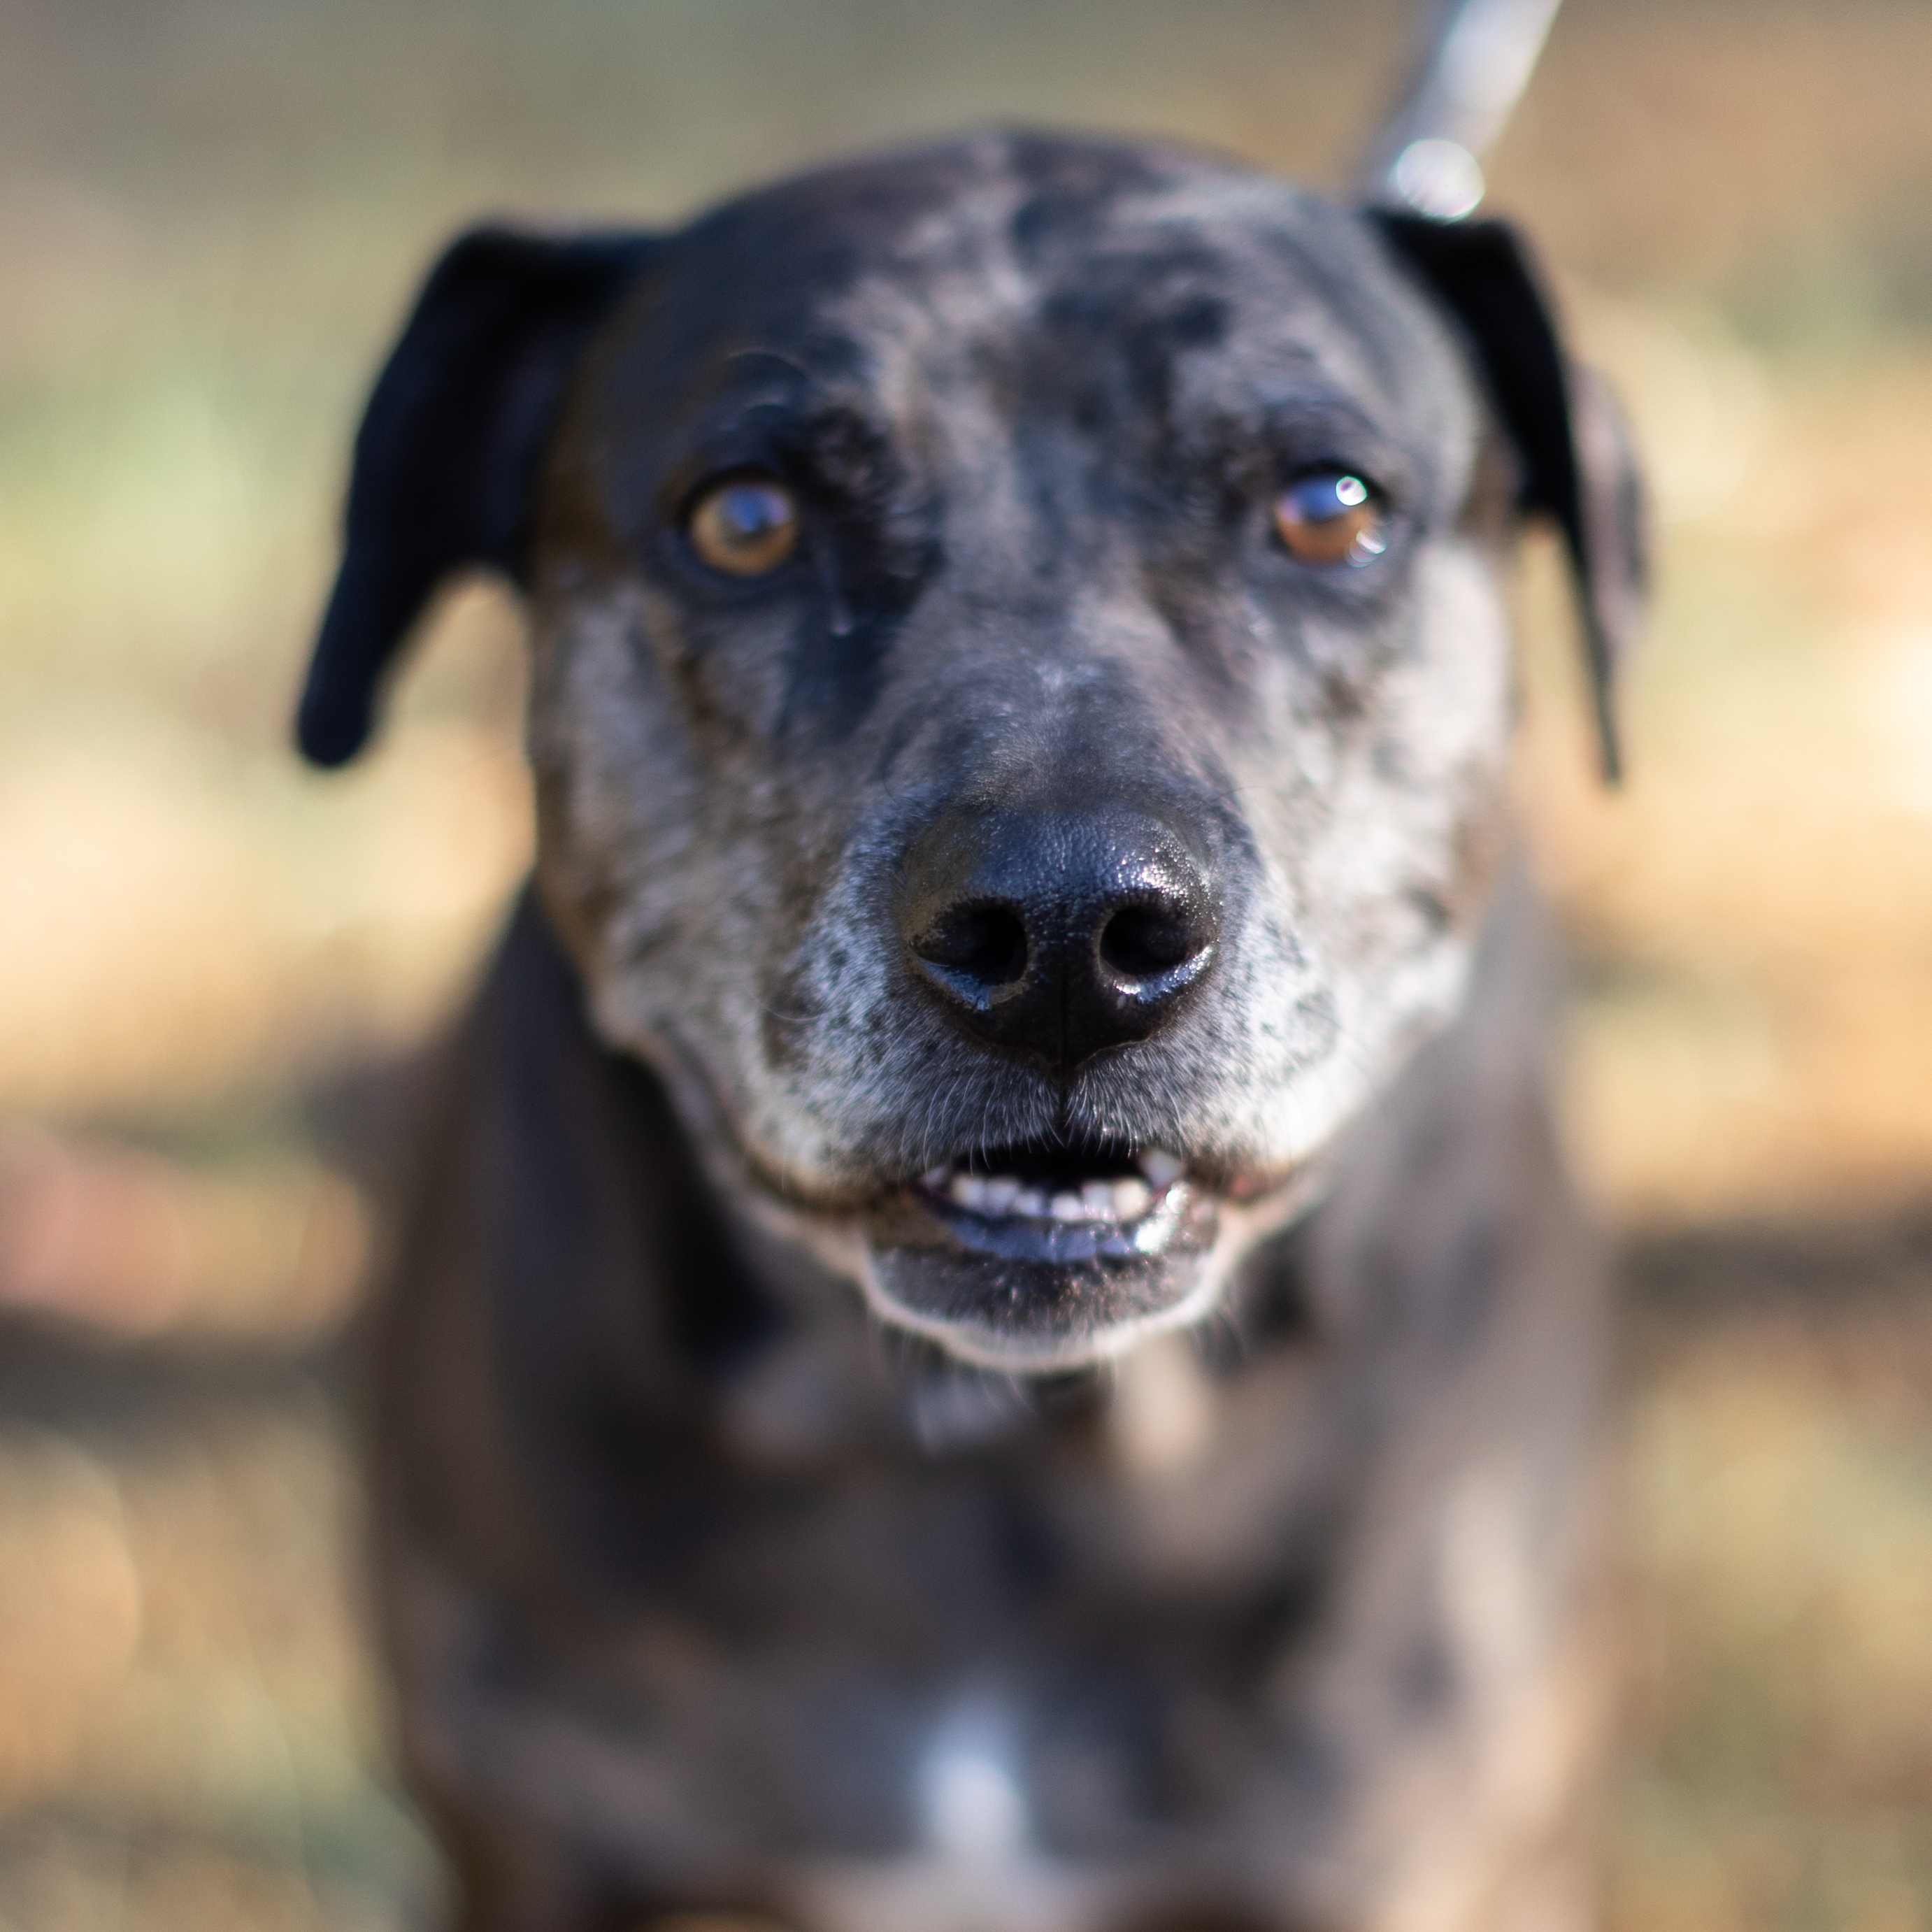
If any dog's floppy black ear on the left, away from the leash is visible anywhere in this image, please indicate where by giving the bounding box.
[296,228,653,765]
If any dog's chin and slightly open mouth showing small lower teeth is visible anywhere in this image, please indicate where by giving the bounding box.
[866,1147,1221,1373]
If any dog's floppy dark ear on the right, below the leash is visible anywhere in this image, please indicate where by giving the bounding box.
[1373,210,1648,785]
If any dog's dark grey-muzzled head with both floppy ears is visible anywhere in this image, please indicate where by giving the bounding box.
[301,135,1638,1368]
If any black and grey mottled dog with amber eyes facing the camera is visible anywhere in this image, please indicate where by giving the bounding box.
[299,134,1643,1932]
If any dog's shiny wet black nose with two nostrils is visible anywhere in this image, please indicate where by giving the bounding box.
[899,810,1219,1072]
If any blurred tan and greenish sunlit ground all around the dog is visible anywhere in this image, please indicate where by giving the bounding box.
[0,0,1932,1932]
